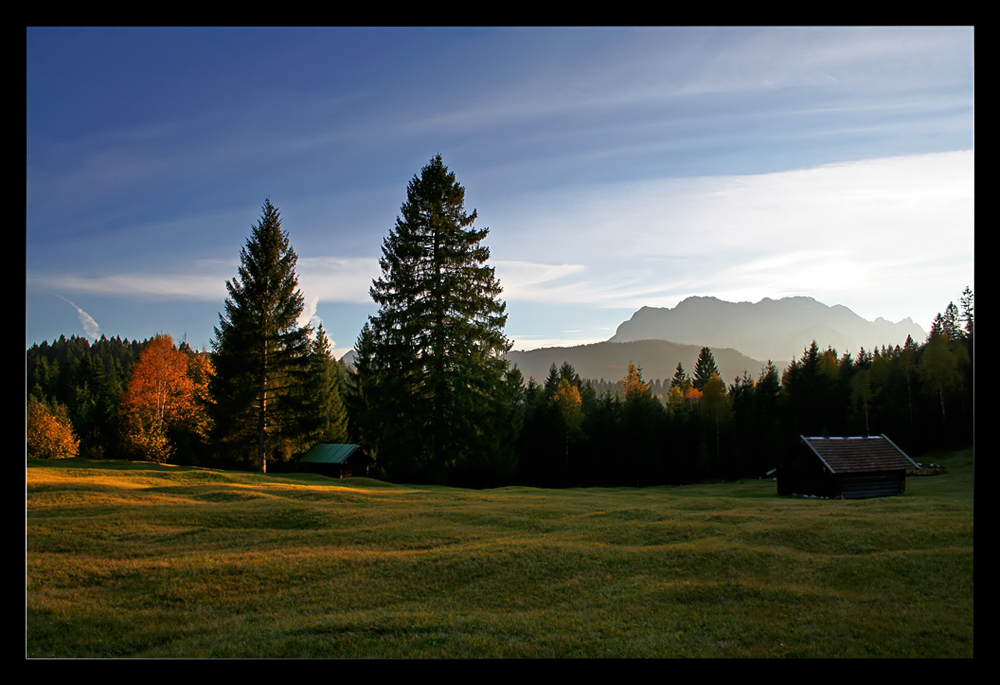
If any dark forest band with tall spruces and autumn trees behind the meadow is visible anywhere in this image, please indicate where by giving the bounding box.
[26,156,974,488]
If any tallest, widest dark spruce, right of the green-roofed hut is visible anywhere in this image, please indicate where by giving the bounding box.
[357,155,510,482]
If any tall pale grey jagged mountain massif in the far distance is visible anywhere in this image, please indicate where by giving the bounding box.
[610,297,927,368]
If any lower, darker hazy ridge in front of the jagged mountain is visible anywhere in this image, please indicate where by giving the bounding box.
[507,340,764,384]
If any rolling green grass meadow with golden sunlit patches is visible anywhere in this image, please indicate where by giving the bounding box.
[26,451,973,657]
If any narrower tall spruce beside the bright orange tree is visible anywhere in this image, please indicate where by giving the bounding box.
[211,198,310,472]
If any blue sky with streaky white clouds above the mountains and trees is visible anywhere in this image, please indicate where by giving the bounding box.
[25,27,975,356]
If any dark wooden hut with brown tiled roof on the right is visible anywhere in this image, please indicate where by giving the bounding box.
[778,435,920,499]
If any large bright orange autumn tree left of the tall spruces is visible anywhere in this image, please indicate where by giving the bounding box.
[119,334,211,462]
